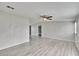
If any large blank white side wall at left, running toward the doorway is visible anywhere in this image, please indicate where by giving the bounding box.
[0,12,29,50]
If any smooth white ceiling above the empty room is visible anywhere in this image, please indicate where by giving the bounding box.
[0,2,79,21]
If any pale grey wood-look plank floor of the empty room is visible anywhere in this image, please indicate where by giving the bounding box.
[0,38,79,56]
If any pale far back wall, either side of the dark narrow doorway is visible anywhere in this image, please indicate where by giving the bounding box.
[32,21,75,41]
